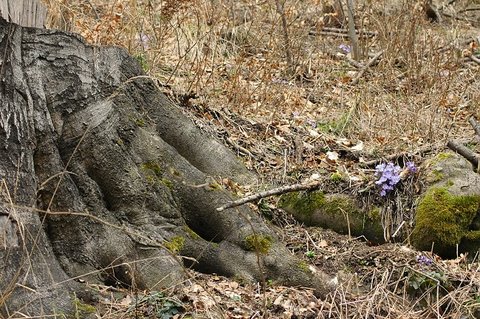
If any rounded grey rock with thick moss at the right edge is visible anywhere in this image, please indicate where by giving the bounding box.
[411,152,480,258]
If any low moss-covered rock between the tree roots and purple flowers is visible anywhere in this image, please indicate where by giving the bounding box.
[279,191,385,243]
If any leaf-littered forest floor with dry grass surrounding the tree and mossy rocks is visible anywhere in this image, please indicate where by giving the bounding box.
[45,0,480,318]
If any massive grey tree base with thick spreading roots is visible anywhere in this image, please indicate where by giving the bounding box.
[0,19,329,315]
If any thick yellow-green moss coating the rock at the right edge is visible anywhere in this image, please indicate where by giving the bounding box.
[412,187,480,256]
